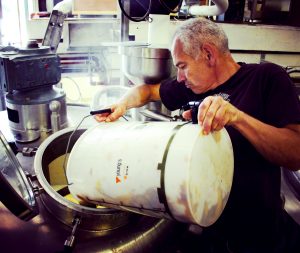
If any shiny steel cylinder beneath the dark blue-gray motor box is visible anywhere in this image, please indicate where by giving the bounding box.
[6,87,67,142]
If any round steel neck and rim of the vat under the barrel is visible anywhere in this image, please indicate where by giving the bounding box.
[34,128,130,233]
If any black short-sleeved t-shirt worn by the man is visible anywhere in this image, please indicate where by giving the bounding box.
[160,63,300,252]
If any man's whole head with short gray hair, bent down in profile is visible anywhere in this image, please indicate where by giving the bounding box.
[171,18,231,94]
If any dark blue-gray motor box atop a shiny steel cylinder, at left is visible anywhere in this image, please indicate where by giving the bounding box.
[0,42,67,142]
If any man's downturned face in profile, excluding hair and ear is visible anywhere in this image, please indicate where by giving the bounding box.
[172,39,213,94]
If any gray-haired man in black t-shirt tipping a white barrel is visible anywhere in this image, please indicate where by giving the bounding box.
[96,18,300,253]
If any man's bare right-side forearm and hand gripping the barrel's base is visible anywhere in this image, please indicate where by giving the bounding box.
[198,97,300,170]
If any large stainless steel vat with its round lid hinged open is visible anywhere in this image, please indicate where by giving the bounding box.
[0,118,187,253]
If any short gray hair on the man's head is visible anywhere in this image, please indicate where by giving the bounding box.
[173,18,229,59]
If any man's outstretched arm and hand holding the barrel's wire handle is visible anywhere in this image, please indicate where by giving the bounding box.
[95,84,160,122]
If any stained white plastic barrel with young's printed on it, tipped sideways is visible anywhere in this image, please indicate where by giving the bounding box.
[67,122,233,226]
